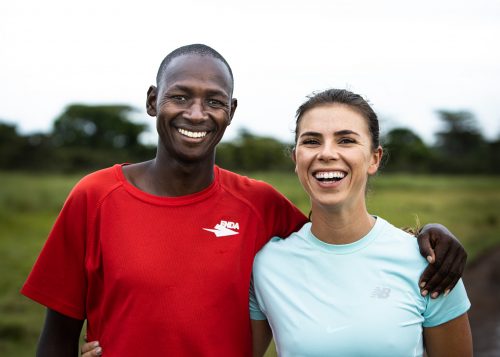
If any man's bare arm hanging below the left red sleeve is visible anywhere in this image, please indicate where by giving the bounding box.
[36,309,83,357]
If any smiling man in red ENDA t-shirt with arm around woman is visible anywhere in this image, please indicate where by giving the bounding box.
[22,45,465,356]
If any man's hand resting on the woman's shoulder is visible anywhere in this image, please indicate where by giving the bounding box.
[417,223,467,298]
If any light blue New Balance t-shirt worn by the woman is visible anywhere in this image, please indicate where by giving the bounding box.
[250,217,470,357]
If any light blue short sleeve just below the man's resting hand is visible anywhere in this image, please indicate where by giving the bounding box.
[423,279,471,327]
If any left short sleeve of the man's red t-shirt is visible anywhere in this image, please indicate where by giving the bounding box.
[21,184,87,320]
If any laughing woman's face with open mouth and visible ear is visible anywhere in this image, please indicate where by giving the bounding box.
[293,104,382,210]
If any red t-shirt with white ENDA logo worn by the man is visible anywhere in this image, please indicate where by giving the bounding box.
[21,165,306,357]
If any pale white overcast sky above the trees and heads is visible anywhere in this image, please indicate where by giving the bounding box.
[0,0,500,143]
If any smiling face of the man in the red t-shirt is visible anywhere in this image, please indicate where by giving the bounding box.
[147,55,237,162]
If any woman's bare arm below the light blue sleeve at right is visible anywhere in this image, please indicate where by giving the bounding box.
[424,313,472,357]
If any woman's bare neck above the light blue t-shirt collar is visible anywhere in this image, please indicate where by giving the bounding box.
[311,205,375,244]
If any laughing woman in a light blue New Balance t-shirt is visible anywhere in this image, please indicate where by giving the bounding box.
[250,89,472,356]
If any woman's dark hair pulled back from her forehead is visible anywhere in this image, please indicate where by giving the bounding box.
[295,88,380,150]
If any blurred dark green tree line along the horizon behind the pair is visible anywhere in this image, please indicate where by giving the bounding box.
[0,104,500,174]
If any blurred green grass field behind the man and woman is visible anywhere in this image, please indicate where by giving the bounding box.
[0,172,500,357]
